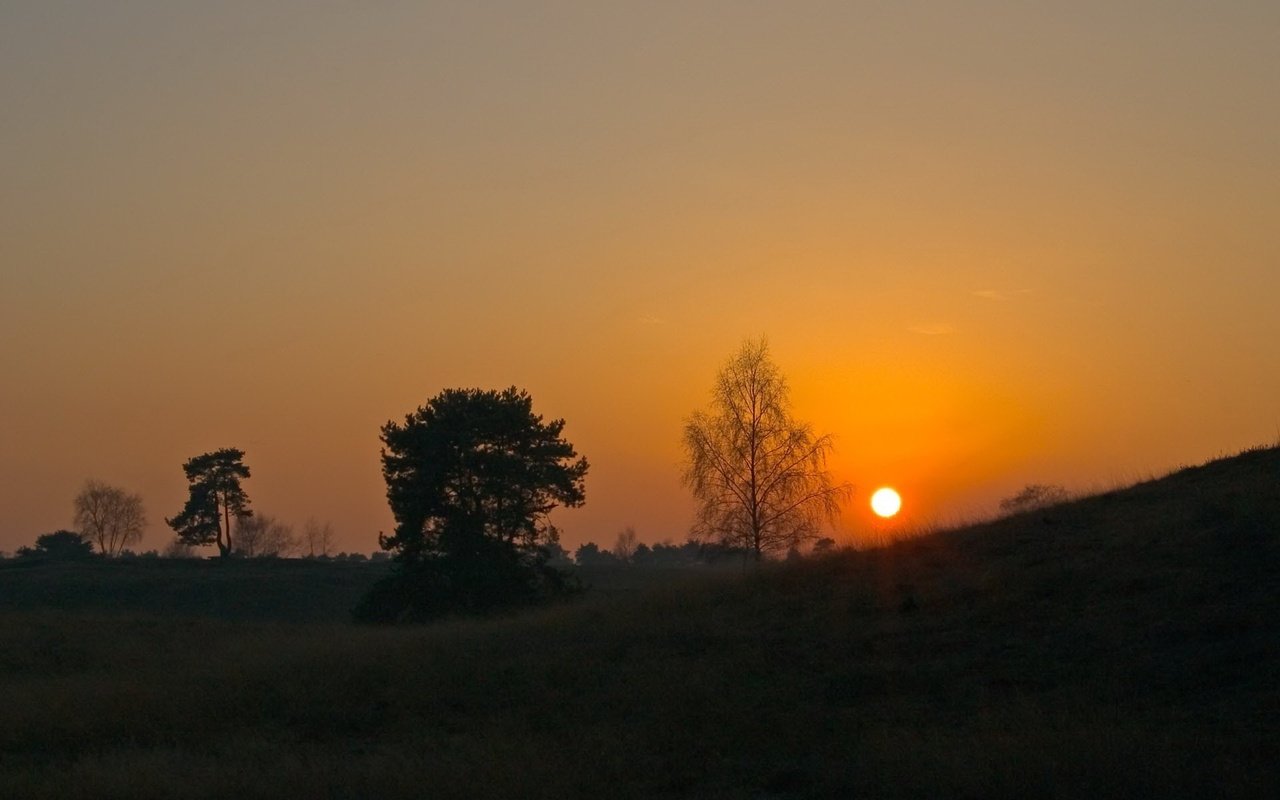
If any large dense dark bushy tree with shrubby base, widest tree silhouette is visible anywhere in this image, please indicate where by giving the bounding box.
[356,388,588,622]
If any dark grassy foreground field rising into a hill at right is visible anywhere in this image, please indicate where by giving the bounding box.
[0,449,1280,797]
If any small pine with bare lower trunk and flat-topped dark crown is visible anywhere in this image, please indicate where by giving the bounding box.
[165,448,253,558]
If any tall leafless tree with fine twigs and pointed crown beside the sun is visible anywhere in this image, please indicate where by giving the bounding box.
[684,339,852,561]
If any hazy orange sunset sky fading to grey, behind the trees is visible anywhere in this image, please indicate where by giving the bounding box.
[0,1,1280,552]
